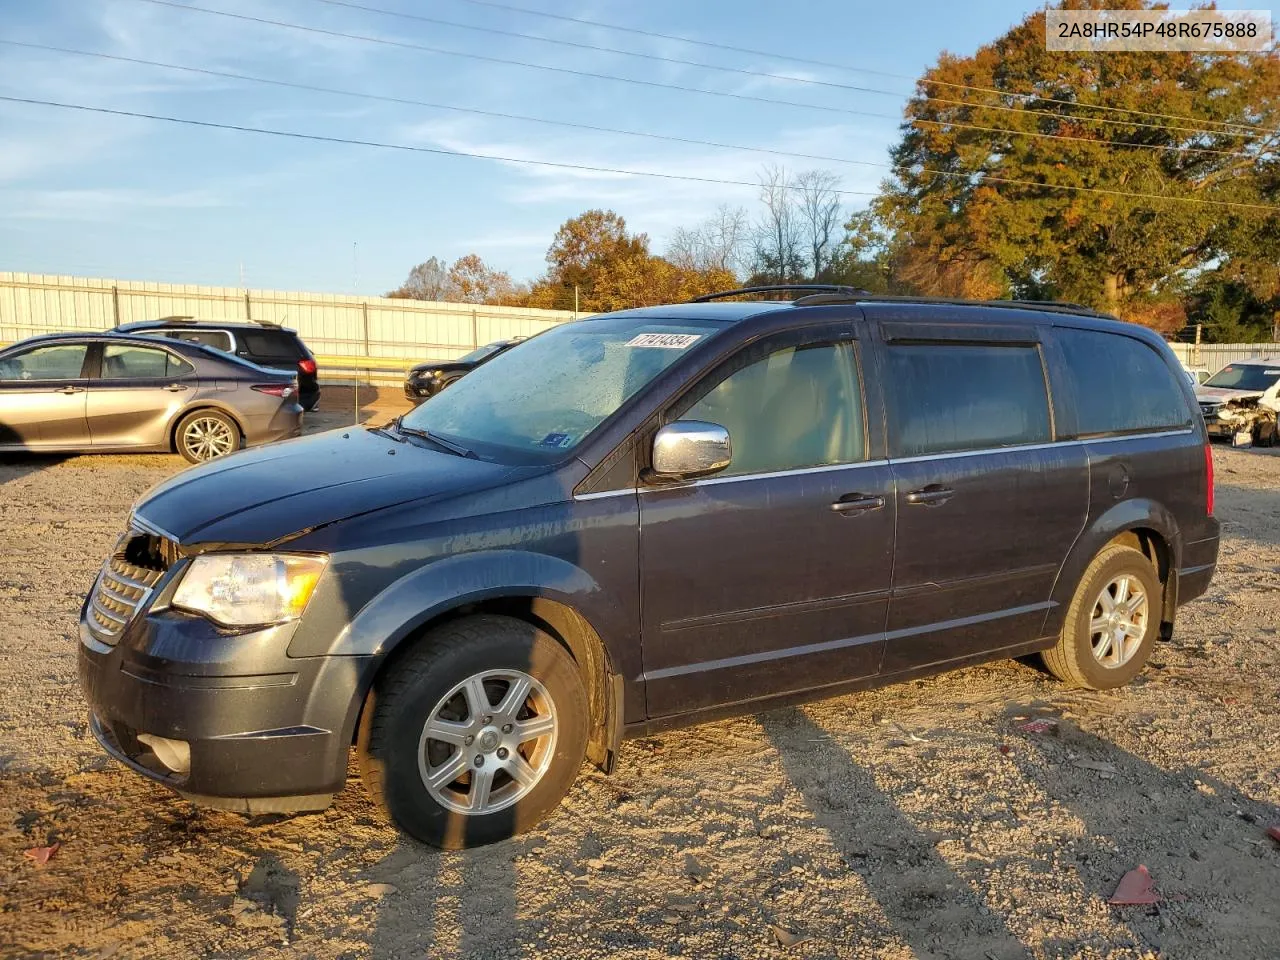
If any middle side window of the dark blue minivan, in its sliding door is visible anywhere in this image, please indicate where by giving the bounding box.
[884,343,1052,457]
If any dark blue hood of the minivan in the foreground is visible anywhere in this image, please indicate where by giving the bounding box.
[134,426,519,545]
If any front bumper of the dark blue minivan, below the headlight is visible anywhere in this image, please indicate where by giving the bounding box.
[79,604,372,813]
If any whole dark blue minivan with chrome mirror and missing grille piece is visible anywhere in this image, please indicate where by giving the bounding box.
[79,289,1219,847]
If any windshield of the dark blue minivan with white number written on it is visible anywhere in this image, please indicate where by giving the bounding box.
[403,317,721,463]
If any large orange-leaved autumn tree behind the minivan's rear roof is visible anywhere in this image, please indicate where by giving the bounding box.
[873,0,1280,326]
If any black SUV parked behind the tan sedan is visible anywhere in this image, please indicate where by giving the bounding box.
[115,316,320,410]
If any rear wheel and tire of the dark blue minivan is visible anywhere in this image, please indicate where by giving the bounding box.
[1041,544,1164,690]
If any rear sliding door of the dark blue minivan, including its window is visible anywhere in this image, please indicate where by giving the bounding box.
[881,324,1089,673]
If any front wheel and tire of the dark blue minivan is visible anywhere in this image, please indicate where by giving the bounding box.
[356,616,590,850]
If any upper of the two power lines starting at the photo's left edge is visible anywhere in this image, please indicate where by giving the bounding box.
[0,38,1269,202]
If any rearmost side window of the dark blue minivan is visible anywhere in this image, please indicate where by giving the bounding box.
[1053,326,1192,436]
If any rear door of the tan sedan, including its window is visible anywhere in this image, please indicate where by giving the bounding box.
[86,342,198,448]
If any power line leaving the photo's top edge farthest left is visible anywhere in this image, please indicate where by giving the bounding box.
[127,0,1249,159]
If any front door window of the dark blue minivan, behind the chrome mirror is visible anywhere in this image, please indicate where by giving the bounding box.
[680,343,865,476]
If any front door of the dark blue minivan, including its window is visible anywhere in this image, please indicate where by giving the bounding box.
[640,326,895,717]
